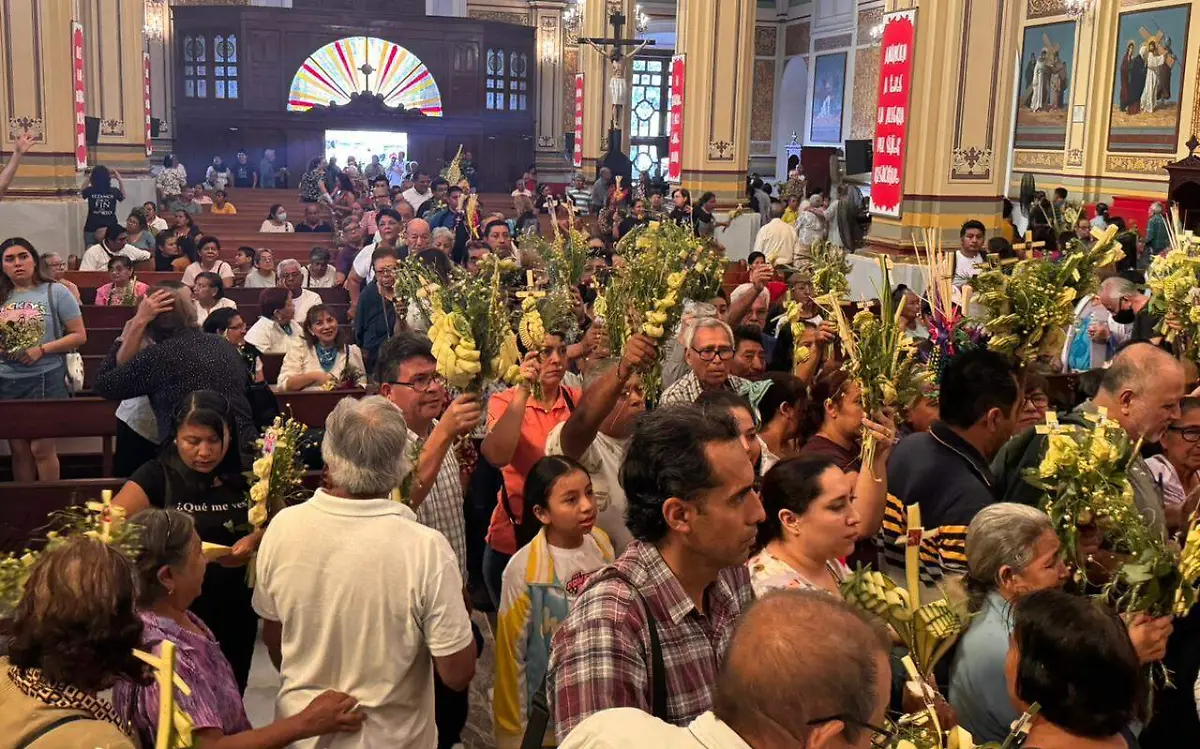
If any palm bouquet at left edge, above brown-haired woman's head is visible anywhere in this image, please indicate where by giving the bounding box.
[0,489,140,619]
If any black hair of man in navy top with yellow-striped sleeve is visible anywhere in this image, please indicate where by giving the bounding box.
[938,348,1020,429]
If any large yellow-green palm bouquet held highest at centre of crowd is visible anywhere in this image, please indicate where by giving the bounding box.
[604,221,725,402]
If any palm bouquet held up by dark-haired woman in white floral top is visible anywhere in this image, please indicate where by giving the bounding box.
[827,257,930,471]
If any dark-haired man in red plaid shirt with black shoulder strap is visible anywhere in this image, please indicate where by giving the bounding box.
[546,405,764,741]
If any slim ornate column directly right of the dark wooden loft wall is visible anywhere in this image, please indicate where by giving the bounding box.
[529,0,574,181]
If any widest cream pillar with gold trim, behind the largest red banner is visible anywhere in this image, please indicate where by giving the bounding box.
[868,0,1022,250]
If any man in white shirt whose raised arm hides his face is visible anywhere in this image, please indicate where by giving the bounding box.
[546,334,658,555]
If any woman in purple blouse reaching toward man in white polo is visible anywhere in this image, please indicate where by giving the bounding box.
[113,508,365,749]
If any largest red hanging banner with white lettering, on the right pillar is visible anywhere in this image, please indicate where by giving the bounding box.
[871,10,917,217]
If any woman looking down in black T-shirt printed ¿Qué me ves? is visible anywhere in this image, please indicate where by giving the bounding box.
[113,390,263,690]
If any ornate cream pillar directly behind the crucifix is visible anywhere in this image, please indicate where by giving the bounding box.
[580,0,637,174]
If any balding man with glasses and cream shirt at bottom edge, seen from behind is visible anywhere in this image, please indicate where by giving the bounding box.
[559,591,894,749]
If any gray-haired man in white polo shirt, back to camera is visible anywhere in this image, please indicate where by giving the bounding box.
[254,396,475,749]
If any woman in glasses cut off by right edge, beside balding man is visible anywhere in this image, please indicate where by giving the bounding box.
[1146,396,1200,533]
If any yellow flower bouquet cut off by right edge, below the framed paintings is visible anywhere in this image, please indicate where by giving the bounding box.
[1146,208,1200,359]
